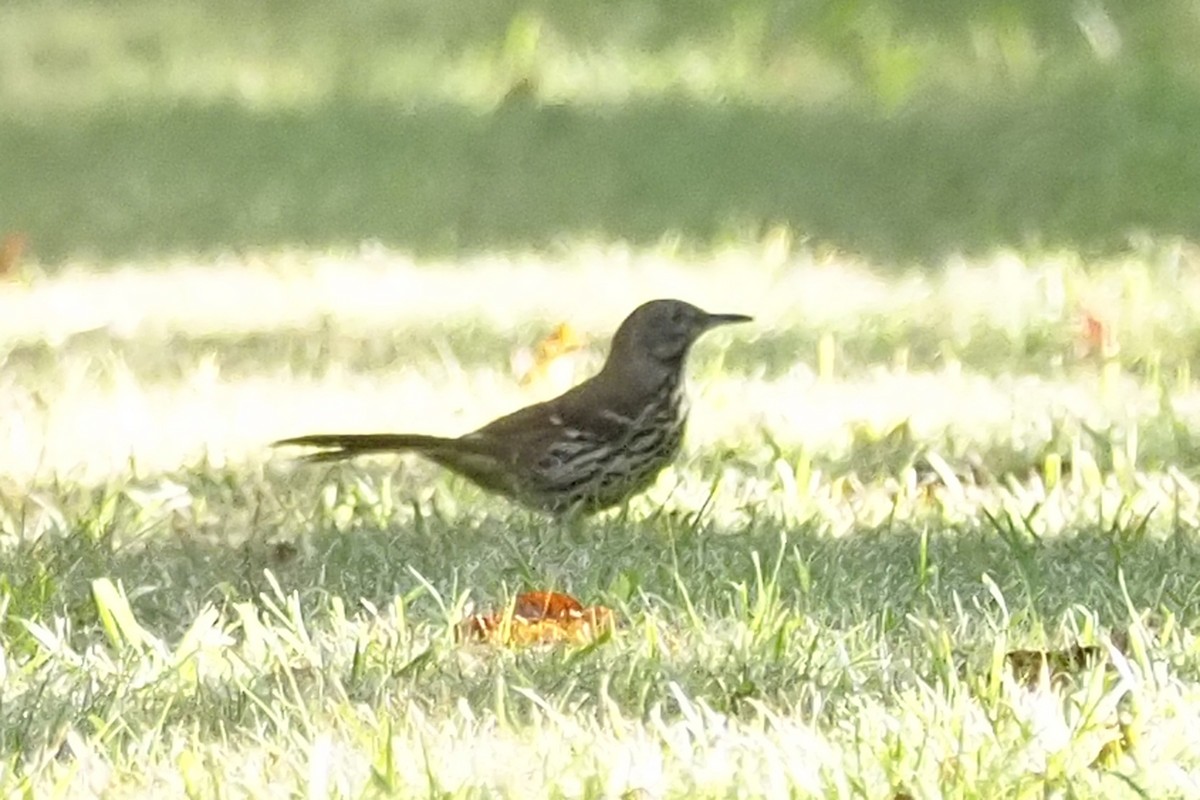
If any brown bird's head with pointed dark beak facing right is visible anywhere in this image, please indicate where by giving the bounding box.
[608,300,752,366]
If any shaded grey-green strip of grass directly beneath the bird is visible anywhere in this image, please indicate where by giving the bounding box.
[7,459,1200,652]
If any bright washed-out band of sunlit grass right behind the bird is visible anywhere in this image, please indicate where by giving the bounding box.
[0,247,1200,489]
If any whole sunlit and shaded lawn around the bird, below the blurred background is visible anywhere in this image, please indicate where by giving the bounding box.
[0,248,1200,796]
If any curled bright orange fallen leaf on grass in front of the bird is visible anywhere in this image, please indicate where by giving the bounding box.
[458,591,616,646]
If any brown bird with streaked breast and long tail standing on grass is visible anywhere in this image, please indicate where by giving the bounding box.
[272,300,752,516]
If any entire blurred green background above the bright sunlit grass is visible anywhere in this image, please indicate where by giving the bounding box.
[0,0,1200,269]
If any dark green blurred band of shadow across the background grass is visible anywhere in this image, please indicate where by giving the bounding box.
[9,65,1200,263]
